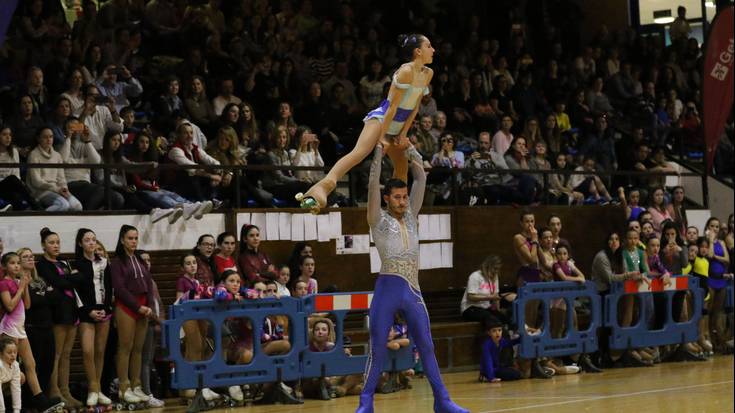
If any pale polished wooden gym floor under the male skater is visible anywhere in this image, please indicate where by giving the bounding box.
[156,356,734,413]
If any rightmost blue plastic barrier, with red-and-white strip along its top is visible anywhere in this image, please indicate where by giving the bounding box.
[604,276,704,350]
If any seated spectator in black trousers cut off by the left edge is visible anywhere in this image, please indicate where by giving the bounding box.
[0,126,39,211]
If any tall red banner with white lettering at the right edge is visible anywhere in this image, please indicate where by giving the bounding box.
[703,6,735,172]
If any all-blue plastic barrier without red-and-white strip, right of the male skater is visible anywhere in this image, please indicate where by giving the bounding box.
[513,281,602,359]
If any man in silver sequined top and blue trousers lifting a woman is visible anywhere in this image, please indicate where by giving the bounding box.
[357,143,469,413]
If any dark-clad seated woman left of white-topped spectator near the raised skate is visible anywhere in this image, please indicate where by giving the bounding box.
[262,126,310,206]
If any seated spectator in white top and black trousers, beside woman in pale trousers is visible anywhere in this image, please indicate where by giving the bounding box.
[60,118,125,211]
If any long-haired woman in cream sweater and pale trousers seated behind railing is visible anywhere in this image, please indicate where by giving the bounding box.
[26,128,82,211]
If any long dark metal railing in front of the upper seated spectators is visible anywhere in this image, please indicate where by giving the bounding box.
[0,162,709,209]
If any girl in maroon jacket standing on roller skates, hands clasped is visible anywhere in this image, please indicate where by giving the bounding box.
[110,225,154,403]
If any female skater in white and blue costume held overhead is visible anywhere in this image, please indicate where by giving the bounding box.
[296,34,434,213]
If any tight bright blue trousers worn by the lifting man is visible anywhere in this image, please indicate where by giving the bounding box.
[360,274,449,404]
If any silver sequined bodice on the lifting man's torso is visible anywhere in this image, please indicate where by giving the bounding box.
[371,208,420,290]
